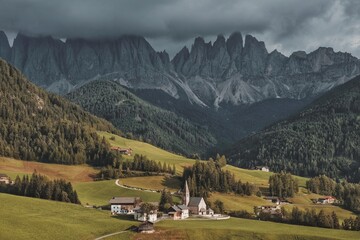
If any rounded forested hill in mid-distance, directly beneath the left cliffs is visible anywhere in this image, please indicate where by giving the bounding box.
[67,80,216,155]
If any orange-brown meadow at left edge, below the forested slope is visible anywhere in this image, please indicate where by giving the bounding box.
[0,157,98,183]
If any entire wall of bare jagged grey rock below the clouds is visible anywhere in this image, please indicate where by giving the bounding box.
[0,32,360,107]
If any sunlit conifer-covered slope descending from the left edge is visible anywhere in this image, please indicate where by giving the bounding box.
[0,59,120,165]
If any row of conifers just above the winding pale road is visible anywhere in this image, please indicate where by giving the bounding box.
[98,154,176,179]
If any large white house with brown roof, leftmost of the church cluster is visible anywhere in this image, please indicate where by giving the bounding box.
[109,197,141,214]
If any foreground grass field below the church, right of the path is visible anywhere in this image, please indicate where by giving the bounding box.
[131,218,360,240]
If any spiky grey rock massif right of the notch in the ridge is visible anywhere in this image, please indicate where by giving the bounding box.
[172,33,360,106]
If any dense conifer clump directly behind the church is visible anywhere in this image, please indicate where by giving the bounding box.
[182,159,261,199]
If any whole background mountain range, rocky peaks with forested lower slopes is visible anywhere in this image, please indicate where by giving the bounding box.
[0,32,360,162]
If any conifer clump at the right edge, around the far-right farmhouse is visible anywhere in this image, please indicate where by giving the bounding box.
[306,175,360,213]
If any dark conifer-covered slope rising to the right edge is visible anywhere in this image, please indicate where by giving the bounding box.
[227,77,360,181]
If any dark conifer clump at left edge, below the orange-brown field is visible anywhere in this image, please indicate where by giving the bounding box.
[0,172,80,204]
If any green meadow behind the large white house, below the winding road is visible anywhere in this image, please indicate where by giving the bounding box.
[74,180,160,206]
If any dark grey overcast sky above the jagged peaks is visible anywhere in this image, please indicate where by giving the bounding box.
[0,0,360,57]
